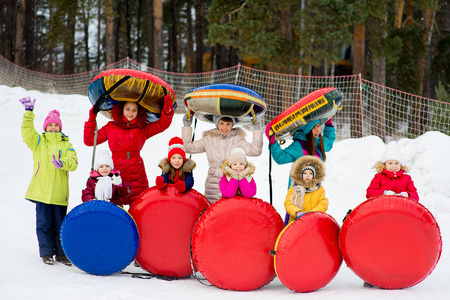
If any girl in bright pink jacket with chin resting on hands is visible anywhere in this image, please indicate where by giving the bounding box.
[219,148,256,198]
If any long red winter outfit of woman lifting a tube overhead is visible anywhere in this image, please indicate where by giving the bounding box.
[84,102,174,204]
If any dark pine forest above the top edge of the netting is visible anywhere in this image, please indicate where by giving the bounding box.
[0,0,450,102]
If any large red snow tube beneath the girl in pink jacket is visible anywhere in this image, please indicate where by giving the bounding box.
[192,196,284,291]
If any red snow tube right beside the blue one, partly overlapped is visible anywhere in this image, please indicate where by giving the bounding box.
[129,184,210,278]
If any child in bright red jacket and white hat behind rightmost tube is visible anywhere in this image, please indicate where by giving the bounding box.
[366,145,419,201]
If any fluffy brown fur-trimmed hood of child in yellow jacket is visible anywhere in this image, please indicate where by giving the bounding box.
[290,155,325,188]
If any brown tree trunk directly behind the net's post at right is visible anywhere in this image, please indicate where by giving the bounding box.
[350,24,365,138]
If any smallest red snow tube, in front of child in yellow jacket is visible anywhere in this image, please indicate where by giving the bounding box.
[275,212,342,292]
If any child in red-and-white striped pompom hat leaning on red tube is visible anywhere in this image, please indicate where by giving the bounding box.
[156,137,195,192]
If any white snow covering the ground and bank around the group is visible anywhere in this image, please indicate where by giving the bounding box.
[0,86,450,300]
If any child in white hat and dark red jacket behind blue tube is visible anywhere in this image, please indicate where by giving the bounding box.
[81,150,131,207]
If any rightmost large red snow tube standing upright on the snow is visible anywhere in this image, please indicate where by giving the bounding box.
[339,196,442,289]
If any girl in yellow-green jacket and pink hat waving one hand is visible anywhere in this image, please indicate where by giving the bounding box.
[19,97,78,266]
